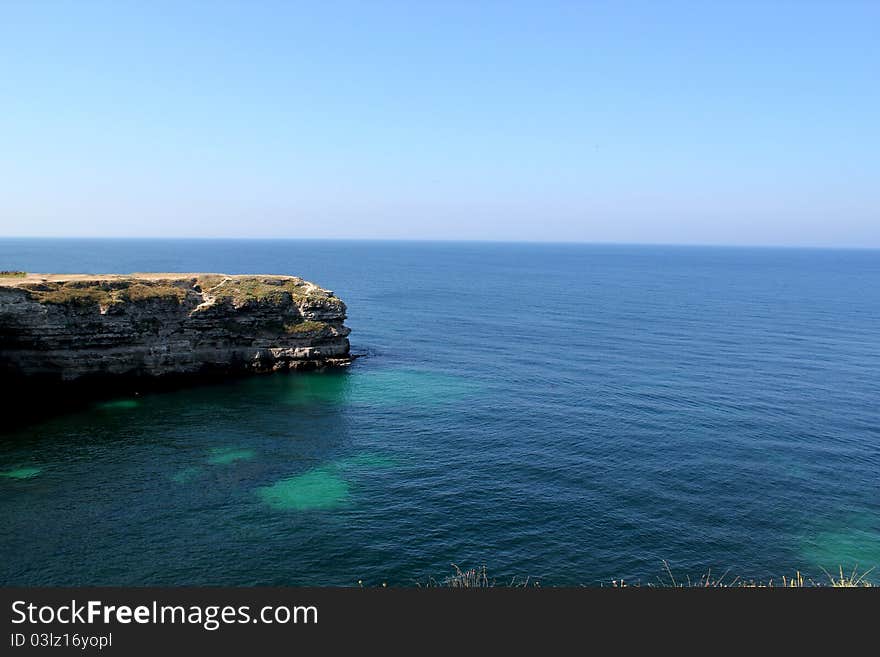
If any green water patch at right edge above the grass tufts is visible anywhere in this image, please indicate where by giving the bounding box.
[801,516,880,582]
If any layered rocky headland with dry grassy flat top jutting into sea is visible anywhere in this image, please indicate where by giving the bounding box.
[0,274,350,385]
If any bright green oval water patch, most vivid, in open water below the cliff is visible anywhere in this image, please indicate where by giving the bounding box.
[257,468,350,511]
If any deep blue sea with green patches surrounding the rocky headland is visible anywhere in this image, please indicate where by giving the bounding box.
[0,240,880,585]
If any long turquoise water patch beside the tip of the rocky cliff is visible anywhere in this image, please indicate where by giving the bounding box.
[287,368,479,406]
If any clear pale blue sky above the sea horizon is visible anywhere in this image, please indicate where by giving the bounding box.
[0,0,880,247]
